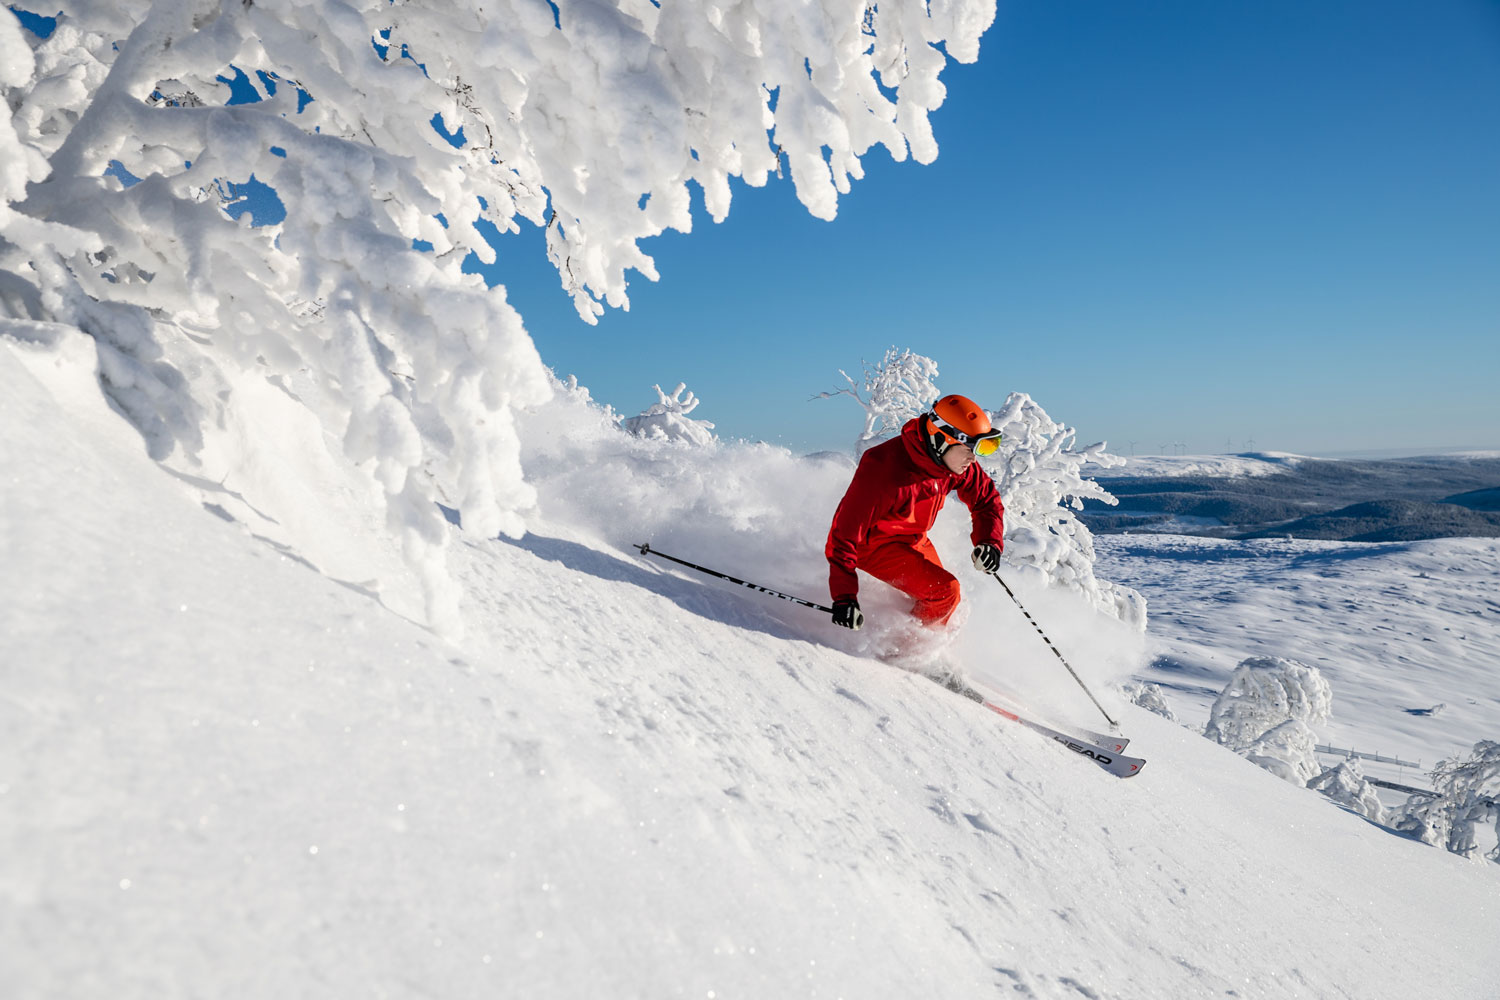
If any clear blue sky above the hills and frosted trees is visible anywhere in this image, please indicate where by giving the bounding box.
[491,0,1500,454]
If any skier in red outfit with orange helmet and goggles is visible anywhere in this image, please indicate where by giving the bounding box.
[825,396,1005,628]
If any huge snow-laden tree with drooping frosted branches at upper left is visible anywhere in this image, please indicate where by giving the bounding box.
[11,0,995,625]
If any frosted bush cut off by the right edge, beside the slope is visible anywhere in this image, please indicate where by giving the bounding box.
[1395,739,1500,862]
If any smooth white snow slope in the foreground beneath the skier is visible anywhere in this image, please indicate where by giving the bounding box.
[0,332,1500,1000]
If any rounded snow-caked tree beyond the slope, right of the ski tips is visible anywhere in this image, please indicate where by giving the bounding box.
[1203,657,1334,784]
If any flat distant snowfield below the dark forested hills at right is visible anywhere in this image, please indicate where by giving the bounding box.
[1095,534,1500,784]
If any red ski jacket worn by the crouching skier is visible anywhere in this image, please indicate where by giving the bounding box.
[825,418,1005,601]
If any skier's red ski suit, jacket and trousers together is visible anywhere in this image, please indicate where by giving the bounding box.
[825,418,1005,625]
